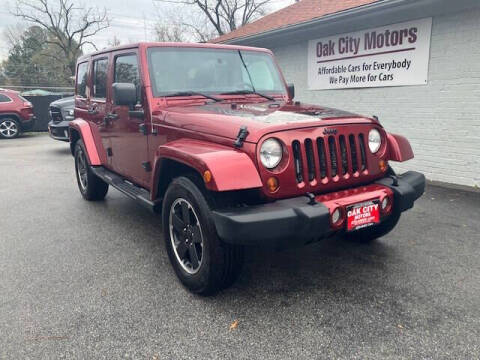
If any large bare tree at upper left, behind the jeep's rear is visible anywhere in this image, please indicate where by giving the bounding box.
[12,0,109,75]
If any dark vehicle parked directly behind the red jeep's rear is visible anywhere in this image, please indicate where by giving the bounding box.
[48,96,75,142]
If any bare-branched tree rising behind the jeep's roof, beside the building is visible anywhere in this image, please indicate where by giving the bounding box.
[156,0,273,40]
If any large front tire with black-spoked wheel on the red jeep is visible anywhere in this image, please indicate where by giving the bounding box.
[162,176,243,295]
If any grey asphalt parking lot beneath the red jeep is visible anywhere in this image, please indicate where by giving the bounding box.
[0,134,480,359]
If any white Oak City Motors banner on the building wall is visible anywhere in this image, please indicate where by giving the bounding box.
[308,18,432,90]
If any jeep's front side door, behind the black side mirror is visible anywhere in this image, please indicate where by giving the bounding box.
[109,49,149,187]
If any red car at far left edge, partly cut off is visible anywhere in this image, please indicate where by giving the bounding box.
[0,89,35,139]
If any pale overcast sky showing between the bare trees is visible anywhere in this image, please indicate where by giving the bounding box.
[0,0,294,60]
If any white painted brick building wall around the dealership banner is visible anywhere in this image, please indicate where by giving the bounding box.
[272,9,480,187]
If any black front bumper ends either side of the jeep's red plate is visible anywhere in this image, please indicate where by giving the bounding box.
[213,171,425,246]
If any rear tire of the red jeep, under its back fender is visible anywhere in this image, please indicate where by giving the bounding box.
[74,140,108,201]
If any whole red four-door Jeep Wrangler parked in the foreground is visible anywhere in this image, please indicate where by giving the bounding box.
[70,43,425,294]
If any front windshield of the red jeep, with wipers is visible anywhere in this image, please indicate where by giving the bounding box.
[148,47,285,97]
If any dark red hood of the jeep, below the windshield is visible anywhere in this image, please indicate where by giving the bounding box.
[164,102,376,143]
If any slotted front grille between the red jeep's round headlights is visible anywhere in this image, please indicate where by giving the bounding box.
[292,134,367,183]
